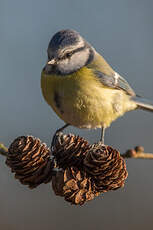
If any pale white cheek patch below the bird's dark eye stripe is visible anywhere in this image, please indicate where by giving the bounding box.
[58,50,89,74]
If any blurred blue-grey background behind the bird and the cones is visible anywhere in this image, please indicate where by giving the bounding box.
[0,0,153,230]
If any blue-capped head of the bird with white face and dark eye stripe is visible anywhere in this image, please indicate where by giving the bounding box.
[44,29,95,75]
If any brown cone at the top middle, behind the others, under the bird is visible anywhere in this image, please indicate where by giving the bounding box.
[53,133,90,169]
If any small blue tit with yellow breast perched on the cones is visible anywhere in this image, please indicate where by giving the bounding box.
[41,29,153,144]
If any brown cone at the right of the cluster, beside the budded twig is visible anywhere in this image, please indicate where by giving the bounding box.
[84,143,128,192]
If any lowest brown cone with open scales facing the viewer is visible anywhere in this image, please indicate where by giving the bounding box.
[52,167,99,205]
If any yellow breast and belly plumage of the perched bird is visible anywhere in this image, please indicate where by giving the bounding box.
[41,67,136,128]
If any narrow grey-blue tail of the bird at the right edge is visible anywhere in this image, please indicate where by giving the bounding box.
[133,96,153,112]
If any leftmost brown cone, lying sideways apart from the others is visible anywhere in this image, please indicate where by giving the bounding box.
[6,136,54,188]
